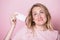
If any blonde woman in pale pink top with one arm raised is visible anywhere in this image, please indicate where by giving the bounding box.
[5,3,58,40]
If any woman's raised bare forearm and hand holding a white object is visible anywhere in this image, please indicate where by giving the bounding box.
[5,14,16,40]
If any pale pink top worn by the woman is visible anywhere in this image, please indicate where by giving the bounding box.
[12,28,58,40]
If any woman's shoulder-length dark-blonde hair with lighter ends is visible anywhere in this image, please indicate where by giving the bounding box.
[25,3,53,30]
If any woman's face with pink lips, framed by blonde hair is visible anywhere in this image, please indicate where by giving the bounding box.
[32,7,47,25]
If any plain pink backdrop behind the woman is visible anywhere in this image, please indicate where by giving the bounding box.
[0,0,60,40]
